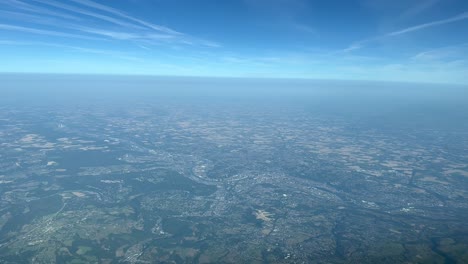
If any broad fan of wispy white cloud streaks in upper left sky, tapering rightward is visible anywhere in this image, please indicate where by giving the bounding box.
[0,0,220,47]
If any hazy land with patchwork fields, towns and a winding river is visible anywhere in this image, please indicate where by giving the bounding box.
[0,76,468,263]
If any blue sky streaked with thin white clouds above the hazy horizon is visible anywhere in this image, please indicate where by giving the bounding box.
[0,0,468,84]
